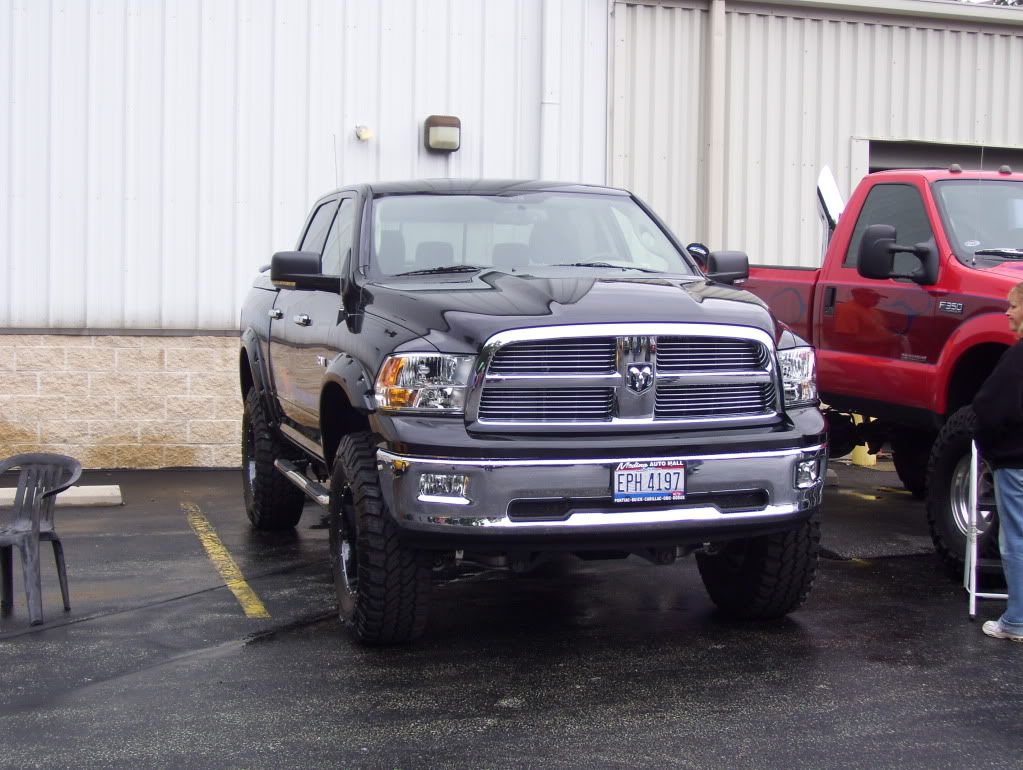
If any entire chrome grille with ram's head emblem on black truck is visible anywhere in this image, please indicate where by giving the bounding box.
[468,324,781,428]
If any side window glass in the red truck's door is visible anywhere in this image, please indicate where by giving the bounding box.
[842,184,934,273]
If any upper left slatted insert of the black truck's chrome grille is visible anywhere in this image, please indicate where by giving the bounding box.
[490,337,615,374]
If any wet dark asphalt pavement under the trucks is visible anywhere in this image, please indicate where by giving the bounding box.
[0,463,1023,768]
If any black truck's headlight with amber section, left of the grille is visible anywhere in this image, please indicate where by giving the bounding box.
[376,353,476,413]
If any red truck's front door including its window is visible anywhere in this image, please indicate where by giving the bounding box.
[813,176,944,408]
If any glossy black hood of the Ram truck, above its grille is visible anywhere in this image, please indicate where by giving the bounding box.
[363,270,780,353]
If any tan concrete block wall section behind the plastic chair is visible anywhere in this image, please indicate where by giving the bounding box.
[0,333,241,468]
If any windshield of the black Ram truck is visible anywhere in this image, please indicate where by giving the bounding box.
[372,192,697,276]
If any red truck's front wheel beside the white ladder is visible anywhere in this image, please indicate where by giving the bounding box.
[927,406,998,575]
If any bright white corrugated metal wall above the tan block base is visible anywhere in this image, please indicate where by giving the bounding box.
[0,0,608,329]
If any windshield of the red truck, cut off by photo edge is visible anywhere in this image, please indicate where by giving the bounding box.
[934,179,1023,261]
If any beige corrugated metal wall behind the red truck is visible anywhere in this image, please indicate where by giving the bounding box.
[611,2,1023,265]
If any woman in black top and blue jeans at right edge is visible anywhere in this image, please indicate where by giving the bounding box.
[973,283,1023,641]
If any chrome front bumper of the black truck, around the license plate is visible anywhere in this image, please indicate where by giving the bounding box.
[376,446,827,544]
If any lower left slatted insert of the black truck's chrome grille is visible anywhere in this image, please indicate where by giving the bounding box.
[480,388,614,422]
